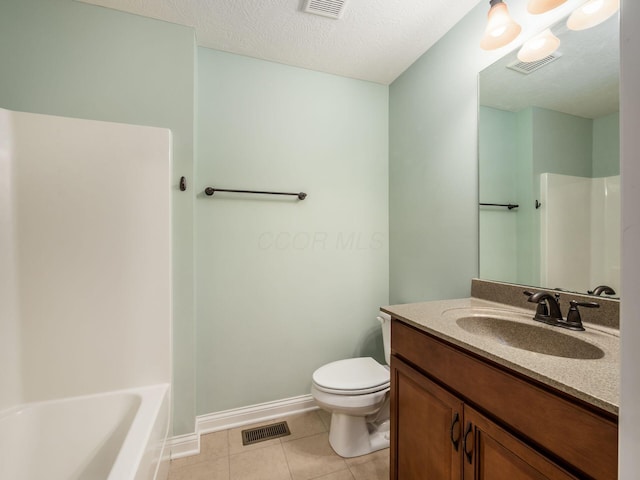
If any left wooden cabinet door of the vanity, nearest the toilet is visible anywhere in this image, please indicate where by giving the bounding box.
[391,357,464,480]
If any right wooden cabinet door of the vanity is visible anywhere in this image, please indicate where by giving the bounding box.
[462,405,576,480]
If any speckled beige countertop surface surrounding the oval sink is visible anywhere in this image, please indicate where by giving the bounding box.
[381,298,620,415]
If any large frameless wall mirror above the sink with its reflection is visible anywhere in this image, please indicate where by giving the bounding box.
[478,15,620,296]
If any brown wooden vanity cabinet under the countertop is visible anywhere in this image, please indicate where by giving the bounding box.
[391,319,617,480]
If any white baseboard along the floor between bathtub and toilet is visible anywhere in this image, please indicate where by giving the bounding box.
[168,395,318,459]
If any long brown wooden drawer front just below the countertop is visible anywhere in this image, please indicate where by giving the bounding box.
[391,320,618,480]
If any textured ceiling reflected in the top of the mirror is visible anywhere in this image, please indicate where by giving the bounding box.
[480,15,620,118]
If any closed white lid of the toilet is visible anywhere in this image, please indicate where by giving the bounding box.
[312,357,389,391]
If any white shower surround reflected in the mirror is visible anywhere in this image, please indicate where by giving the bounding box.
[540,173,620,292]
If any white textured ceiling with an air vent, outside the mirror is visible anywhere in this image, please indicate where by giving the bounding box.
[79,0,480,85]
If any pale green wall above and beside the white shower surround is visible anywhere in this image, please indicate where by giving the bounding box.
[0,0,195,434]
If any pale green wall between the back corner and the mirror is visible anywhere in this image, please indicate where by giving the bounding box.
[389,3,488,303]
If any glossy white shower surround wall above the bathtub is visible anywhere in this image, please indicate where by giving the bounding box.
[0,110,171,409]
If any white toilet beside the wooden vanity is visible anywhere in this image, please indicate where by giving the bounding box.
[311,312,391,458]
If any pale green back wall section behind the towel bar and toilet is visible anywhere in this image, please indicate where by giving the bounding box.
[196,48,389,414]
